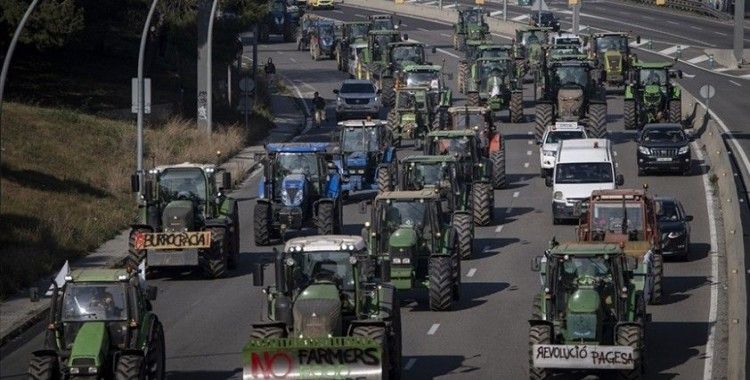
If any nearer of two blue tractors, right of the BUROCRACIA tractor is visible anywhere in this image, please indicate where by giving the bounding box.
[253,143,342,246]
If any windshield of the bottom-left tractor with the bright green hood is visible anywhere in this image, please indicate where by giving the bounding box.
[62,283,128,322]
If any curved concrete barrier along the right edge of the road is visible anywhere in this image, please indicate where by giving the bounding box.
[682,90,748,379]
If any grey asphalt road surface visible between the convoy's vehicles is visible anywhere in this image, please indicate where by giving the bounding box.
[0,7,711,379]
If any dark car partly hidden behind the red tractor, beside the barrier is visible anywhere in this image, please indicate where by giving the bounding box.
[656,197,693,261]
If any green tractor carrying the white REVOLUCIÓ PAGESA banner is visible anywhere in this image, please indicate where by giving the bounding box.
[529,240,648,380]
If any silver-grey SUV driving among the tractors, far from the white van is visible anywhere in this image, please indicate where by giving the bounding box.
[333,79,382,120]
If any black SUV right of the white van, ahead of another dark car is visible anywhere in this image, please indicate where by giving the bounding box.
[636,123,691,175]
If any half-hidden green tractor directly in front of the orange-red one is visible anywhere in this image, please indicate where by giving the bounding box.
[424,129,505,226]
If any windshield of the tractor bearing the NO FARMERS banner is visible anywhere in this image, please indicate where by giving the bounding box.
[294,251,354,290]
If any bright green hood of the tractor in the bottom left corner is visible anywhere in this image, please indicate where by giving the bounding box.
[68,322,109,372]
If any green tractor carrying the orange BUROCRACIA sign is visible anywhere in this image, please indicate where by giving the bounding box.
[128,163,240,278]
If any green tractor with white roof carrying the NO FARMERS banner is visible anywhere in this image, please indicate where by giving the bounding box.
[247,235,401,379]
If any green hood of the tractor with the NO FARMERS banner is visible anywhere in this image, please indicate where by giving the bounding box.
[293,282,341,338]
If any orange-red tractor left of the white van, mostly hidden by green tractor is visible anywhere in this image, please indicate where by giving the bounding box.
[448,106,506,189]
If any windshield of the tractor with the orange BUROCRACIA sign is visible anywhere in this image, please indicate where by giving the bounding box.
[159,168,206,202]
